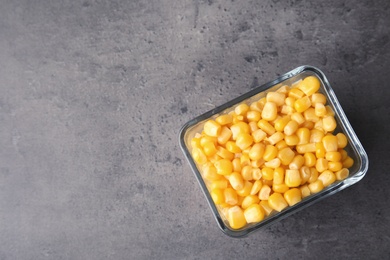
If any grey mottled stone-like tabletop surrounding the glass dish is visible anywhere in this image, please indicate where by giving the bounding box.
[0,0,390,259]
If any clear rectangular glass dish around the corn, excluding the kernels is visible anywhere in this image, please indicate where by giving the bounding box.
[179,66,368,237]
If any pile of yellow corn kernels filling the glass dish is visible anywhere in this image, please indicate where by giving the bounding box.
[191,76,354,229]
